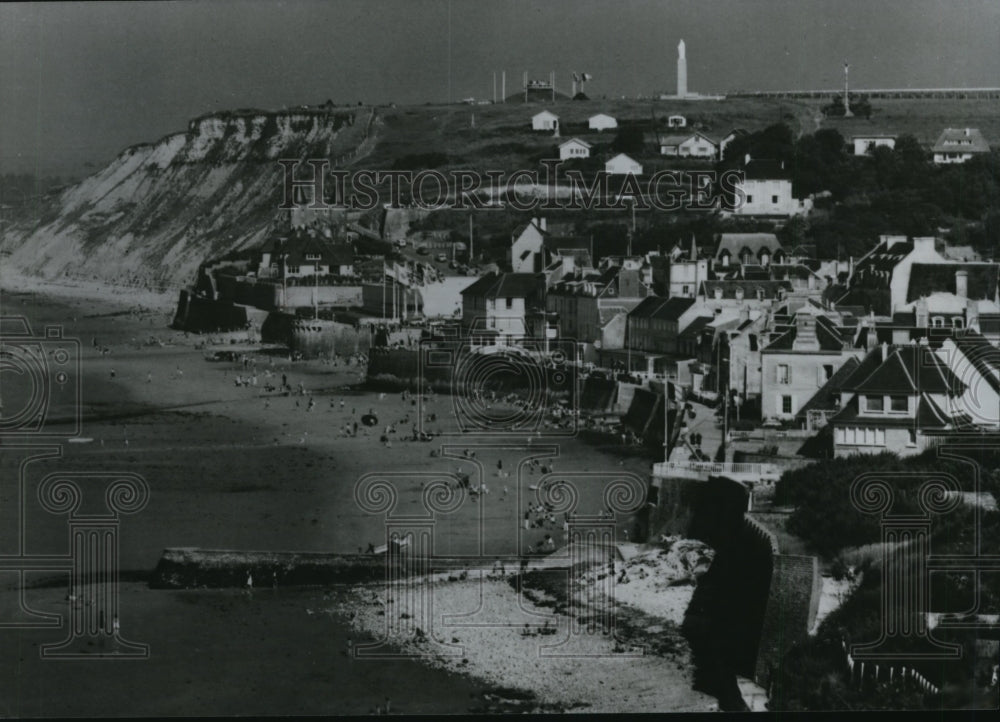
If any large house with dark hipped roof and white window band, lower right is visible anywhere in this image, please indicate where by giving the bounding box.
[829,344,971,456]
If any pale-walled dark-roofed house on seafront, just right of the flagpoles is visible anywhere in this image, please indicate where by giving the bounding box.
[462,273,548,345]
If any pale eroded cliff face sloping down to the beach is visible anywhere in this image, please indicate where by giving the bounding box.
[0,108,376,286]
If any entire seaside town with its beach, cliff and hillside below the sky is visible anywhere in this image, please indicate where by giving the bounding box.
[0,3,1000,717]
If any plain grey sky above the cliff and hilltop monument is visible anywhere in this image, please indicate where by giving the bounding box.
[0,0,1000,175]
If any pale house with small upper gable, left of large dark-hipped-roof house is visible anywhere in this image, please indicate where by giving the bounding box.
[761,306,856,421]
